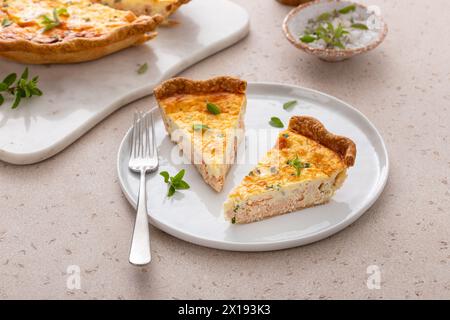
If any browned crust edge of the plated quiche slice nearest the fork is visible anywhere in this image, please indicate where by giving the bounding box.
[153,76,247,100]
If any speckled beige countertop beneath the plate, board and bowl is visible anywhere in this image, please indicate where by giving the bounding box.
[0,0,450,299]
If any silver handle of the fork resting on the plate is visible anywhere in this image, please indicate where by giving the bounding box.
[129,171,152,266]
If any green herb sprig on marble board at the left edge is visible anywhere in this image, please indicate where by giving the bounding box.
[0,68,42,109]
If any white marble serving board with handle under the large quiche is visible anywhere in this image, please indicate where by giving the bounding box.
[0,0,249,164]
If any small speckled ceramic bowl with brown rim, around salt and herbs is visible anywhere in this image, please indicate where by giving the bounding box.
[283,0,388,62]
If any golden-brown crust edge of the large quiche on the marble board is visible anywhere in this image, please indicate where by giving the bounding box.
[0,15,164,55]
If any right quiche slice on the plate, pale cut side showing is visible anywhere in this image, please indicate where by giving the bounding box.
[224,116,356,223]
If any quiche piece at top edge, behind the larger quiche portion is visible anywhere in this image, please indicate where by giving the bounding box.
[93,0,190,19]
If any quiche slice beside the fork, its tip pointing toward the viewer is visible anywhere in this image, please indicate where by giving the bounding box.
[155,77,247,192]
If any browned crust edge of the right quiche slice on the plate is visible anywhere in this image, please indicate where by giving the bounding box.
[289,116,356,167]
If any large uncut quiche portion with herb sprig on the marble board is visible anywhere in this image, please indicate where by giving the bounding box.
[0,0,163,64]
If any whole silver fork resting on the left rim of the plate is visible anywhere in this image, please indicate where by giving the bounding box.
[128,112,158,266]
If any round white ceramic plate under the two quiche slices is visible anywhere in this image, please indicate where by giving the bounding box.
[117,83,389,251]
